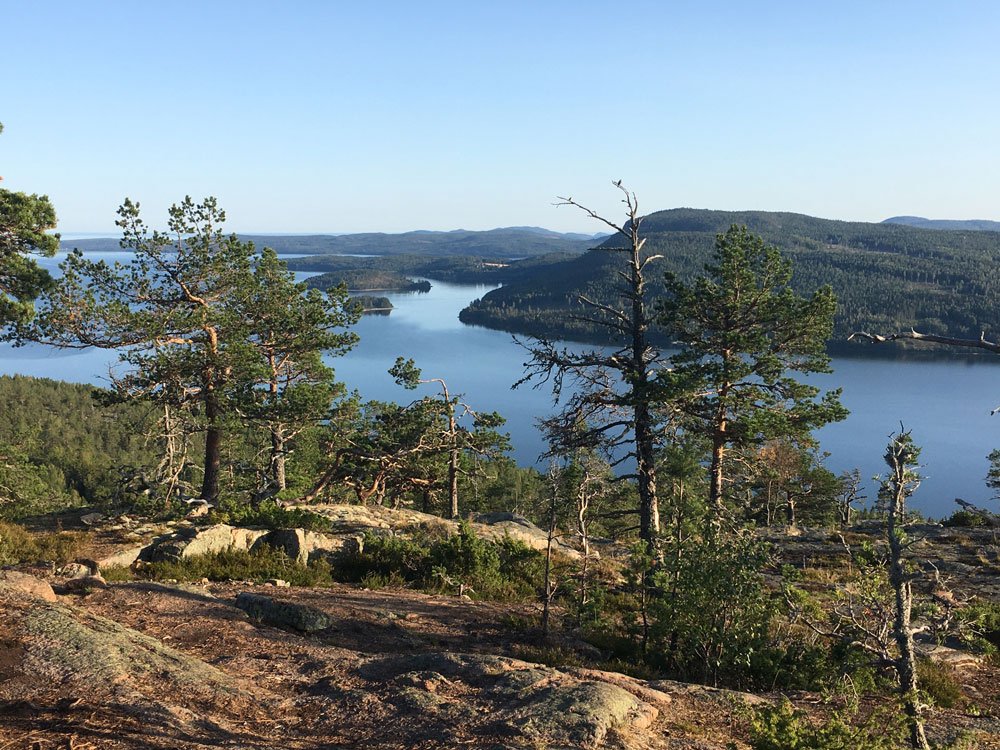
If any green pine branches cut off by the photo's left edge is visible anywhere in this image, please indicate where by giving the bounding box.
[0,124,59,330]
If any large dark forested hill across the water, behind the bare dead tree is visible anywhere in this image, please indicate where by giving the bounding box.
[461,208,1000,348]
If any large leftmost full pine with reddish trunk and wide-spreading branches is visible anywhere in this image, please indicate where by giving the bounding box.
[32,197,262,501]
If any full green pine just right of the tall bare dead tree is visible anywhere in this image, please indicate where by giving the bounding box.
[657,226,847,526]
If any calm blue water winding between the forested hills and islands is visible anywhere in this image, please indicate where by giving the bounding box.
[0,253,1000,517]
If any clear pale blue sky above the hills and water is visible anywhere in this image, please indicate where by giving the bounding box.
[0,0,1000,232]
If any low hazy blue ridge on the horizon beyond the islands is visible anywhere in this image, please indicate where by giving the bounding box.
[63,227,607,259]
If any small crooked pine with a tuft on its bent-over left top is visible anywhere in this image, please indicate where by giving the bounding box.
[389,357,509,519]
